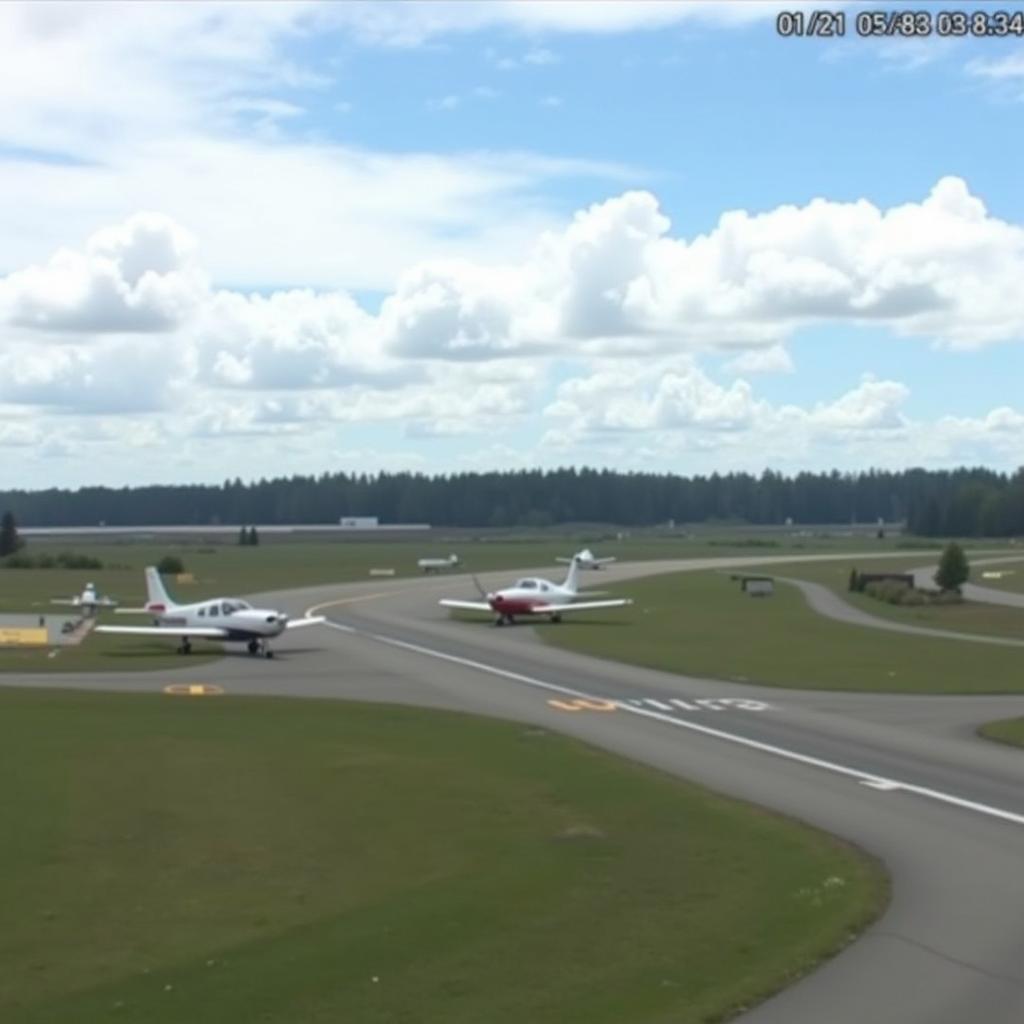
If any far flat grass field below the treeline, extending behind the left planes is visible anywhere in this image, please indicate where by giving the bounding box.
[0,528,1015,674]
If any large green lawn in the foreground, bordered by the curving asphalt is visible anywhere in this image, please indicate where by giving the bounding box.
[0,690,887,1024]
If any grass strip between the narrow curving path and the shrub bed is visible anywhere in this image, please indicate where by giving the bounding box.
[765,554,1024,640]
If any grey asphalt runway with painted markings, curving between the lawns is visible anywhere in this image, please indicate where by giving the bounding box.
[3,555,1024,1024]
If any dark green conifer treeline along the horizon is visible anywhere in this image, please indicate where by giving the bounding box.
[0,468,1024,537]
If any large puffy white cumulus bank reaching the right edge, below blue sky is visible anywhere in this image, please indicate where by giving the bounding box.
[376,177,1024,358]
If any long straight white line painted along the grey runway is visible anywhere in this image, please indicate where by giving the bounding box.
[324,618,1024,825]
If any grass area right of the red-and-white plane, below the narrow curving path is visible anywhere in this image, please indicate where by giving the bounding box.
[537,567,1024,693]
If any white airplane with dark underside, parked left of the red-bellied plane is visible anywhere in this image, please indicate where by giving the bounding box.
[95,565,324,657]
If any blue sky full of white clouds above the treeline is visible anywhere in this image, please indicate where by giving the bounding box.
[0,0,1024,489]
